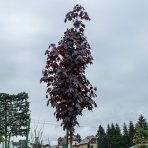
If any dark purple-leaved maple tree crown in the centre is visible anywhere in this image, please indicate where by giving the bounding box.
[41,5,97,143]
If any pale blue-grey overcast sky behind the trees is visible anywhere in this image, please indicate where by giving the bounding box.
[0,0,148,146]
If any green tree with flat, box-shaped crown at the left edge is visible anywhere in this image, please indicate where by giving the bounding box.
[0,92,30,148]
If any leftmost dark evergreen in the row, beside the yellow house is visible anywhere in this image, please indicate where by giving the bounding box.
[96,125,107,148]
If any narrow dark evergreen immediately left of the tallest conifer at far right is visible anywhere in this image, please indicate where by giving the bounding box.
[128,121,135,146]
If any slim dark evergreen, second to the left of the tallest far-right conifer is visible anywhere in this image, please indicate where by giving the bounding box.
[122,123,129,147]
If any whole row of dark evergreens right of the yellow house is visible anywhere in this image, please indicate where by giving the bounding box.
[96,115,148,148]
